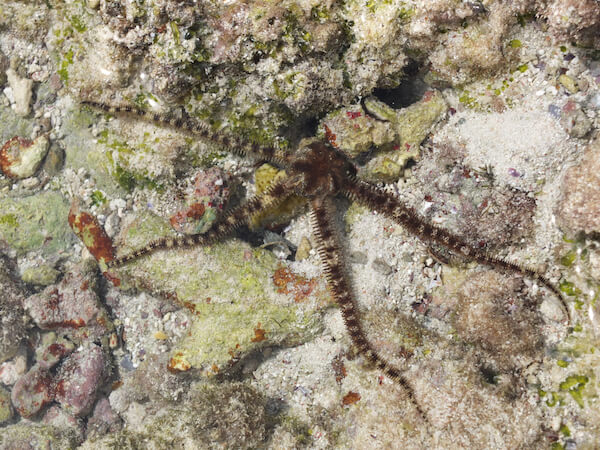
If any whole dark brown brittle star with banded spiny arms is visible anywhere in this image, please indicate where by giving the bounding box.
[82,101,570,416]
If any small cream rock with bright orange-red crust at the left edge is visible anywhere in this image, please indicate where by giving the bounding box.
[0,136,50,179]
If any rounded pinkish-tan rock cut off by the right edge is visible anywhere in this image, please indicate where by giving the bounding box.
[555,139,600,233]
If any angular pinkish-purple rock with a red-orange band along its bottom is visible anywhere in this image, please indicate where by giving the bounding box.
[24,265,112,340]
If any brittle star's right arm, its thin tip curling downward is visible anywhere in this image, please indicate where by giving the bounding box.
[343,179,571,325]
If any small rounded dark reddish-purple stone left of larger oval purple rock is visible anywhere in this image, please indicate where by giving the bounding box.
[11,365,54,417]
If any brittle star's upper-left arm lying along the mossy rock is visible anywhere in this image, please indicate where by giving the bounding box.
[81,100,288,166]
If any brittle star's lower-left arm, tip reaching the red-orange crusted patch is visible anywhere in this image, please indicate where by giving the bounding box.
[107,178,298,269]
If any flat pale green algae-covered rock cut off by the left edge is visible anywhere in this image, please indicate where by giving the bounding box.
[0,192,75,256]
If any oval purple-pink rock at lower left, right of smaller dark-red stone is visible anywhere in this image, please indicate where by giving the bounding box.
[55,344,105,416]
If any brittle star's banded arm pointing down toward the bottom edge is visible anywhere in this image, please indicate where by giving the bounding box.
[310,197,426,419]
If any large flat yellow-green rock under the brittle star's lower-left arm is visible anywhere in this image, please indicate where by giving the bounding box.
[118,213,322,370]
